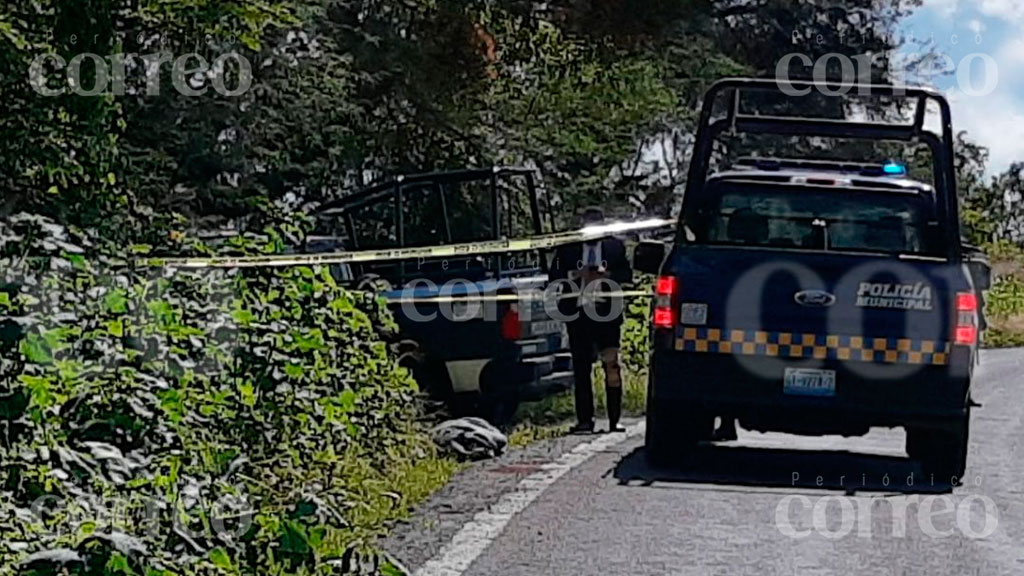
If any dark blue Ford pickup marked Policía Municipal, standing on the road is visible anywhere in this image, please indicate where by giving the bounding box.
[634,79,989,477]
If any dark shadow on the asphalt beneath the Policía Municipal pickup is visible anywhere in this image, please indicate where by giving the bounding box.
[613,444,952,494]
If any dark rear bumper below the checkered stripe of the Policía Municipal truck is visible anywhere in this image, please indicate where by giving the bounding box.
[648,344,970,434]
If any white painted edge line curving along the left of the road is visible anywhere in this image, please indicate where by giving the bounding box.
[414,422,644,576]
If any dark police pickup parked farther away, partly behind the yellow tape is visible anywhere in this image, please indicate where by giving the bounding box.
[305,168,572,423]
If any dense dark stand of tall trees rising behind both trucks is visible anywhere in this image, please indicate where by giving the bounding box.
[0,0,950,237]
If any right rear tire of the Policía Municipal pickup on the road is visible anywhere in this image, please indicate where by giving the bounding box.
[906,408,971,485]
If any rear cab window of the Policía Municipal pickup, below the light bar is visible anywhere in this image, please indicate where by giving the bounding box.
[691,184,943,256]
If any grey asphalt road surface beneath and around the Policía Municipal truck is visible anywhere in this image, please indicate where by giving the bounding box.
[392,351,1024,576]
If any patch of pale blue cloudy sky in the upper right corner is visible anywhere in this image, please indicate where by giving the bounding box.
[900,0,1024,175]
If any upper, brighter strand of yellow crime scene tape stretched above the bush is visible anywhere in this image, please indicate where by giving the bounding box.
[139,218,674,269]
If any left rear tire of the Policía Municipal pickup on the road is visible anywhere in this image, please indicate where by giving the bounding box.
[644,402,715,466]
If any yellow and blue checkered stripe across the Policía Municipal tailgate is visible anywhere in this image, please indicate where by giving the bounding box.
[676,328,951,366]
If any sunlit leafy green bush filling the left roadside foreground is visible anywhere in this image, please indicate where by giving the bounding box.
[0,216,454,575]
